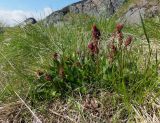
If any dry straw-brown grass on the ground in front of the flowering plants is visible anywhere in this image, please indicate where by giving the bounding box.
[0,91,160,123]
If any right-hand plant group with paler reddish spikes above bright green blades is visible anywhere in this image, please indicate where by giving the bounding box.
[104,24,158,103]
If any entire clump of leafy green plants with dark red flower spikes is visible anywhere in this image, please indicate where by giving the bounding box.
[31,24,159,103]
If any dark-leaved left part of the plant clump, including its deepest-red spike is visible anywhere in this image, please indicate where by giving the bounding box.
[31,25,101,100]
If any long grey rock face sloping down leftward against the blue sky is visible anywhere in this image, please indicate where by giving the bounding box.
[44,0,125,24]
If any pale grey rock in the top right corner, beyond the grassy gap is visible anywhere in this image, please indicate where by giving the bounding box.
[121,0,160,24]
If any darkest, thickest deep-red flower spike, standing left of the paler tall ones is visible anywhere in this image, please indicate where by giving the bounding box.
[88,25,101,55]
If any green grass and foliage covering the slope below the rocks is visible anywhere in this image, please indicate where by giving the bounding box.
[0,15,160,122]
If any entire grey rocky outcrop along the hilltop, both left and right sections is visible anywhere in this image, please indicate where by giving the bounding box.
[44,0,160,25]
